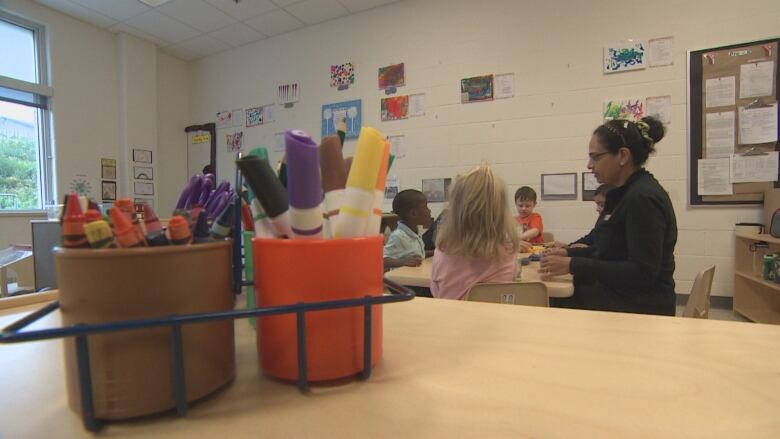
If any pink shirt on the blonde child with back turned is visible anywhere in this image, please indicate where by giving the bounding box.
[431,249,517,300]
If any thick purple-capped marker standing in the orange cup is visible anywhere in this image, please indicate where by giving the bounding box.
[284,130,322,239]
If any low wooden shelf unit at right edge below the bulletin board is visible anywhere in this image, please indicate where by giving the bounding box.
[734,233,780,324]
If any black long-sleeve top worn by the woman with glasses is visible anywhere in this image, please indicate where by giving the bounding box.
[567,169,677,315]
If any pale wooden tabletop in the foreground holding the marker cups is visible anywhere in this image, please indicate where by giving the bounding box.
[0,298,780,439]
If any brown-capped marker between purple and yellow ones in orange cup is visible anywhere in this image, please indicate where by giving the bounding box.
[320,136,347,238]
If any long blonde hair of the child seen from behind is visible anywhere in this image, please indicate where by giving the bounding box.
[436,165,518,259]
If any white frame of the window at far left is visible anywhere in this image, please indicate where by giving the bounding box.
[0,9,57,216]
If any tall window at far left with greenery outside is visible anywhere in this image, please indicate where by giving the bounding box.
[0,11,55,212]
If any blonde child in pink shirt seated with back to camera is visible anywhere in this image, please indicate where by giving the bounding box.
[431,165,528,300]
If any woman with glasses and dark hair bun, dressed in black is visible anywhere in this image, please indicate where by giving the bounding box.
[541,117,677,315]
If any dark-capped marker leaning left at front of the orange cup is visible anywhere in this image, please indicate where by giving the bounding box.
[236,156,293,238]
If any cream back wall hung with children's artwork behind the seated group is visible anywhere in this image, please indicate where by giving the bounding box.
[190,0,780,296]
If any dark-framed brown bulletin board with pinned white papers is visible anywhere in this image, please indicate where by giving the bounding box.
[688,38,780,206]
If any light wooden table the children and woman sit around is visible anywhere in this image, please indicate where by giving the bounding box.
[385,253,574,297]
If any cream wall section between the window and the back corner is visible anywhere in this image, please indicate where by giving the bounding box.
[0,0,188,248]
